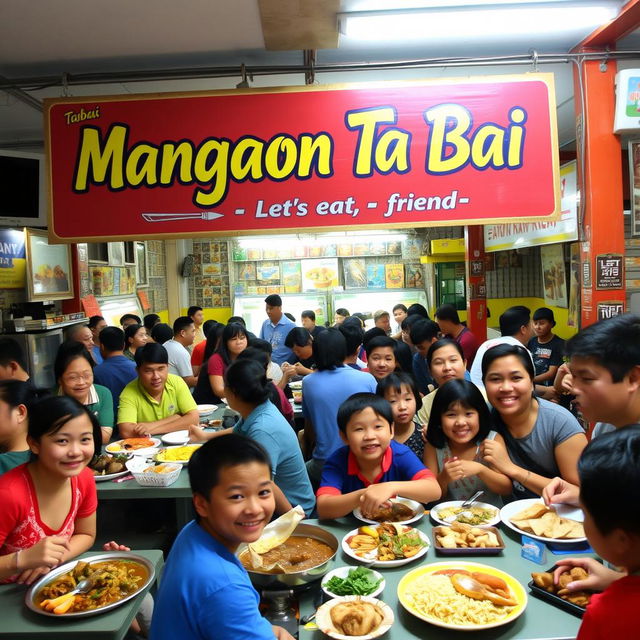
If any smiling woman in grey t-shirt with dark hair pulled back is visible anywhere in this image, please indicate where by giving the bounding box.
[482,344,587,500]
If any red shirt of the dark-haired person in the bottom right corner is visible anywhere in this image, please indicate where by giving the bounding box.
[577,576,640,640]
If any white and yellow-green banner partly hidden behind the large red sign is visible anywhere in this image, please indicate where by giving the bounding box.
[484,160,578,252]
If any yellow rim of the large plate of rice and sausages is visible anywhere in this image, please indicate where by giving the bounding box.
[398,561,527,631]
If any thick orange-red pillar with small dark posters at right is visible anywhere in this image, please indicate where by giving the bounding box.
[574,61,626,327]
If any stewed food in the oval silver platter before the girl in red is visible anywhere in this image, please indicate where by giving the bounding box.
[35,560,149,615]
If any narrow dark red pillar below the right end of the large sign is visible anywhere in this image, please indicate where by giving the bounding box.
[464,224,487,342]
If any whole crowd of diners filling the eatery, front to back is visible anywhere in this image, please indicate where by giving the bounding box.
[0,294,640,638]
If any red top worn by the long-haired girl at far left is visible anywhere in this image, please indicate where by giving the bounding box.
[0,464,98,582]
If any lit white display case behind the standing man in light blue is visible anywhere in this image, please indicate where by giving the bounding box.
[233,291,333,336]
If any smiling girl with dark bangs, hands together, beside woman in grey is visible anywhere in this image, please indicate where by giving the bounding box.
[425,379,511,506]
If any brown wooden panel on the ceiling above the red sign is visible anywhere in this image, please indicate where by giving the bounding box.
[258,0,340,51]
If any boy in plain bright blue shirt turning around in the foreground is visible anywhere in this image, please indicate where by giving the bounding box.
[151,434,293,640]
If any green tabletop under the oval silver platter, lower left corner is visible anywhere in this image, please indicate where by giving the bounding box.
[0,549,164,640]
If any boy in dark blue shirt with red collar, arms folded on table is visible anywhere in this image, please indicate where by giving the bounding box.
[316,393,441,518]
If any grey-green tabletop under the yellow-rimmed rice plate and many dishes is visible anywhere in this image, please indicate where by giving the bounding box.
[299,514,593,640]
